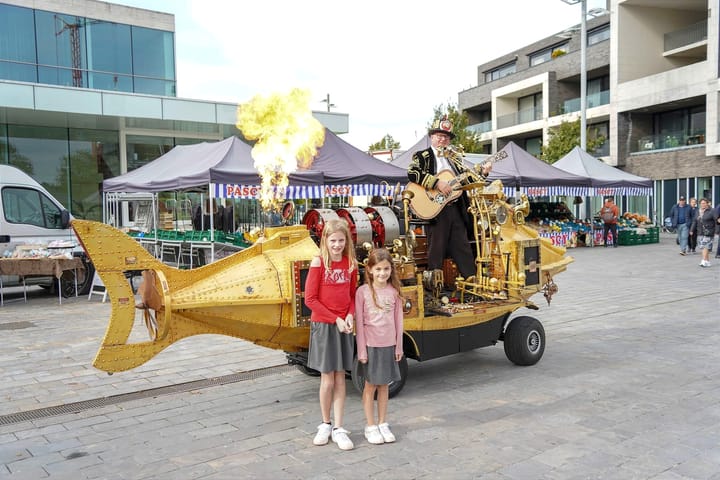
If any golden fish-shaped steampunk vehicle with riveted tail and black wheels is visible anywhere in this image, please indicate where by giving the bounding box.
[72,155,573,395]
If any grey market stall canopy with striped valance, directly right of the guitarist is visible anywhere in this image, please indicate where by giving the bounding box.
[489,142,590,196]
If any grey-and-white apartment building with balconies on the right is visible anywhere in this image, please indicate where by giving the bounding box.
[458,0,720,218]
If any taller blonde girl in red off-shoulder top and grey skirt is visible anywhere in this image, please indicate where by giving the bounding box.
[305,219,358,450]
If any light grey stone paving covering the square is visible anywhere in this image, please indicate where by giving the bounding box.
[0,234,720,480]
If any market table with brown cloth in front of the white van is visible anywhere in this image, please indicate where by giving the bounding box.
[0,257,85,305]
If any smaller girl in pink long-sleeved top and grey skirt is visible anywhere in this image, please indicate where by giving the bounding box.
[355,248,403,444]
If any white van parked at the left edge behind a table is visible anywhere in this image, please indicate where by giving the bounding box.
[0,165,95,295]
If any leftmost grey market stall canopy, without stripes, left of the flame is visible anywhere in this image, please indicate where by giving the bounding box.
[103,135,323,193]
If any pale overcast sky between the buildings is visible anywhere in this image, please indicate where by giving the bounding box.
[113,0,605,150]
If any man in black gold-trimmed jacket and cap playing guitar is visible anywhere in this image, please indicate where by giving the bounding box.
[408,118,492,278]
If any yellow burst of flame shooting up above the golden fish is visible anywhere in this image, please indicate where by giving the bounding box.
[237,88,325,211]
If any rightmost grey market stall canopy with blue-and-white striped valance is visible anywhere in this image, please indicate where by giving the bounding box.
[553,147,653,195]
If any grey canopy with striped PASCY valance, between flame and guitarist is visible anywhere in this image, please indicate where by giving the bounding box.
[211,128,407,198]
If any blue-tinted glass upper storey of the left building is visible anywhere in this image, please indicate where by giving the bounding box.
[0,4,176,97]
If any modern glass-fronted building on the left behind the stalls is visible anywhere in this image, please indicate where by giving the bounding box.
[0,0,348,220]
